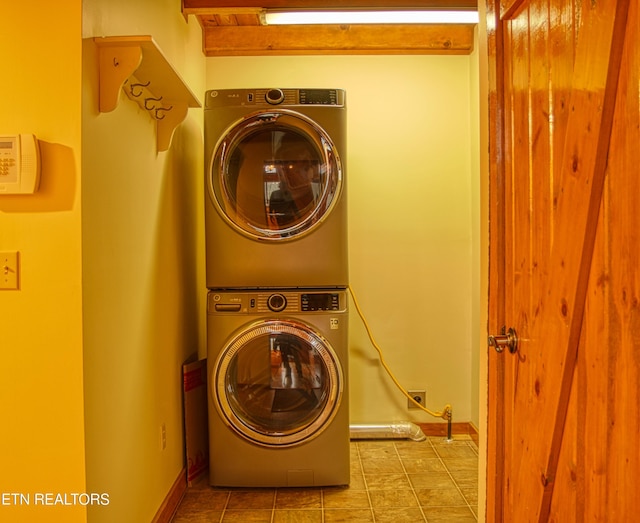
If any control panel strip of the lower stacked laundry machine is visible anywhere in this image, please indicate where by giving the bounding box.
[208,289,347,314]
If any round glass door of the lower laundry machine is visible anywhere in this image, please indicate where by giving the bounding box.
[212,320,344,447]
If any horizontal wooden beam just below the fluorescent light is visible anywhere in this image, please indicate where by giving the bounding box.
[204,24,474,56]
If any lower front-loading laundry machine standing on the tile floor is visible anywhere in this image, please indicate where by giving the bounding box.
[207,289,350,487]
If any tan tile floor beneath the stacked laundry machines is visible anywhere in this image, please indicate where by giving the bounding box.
[172,436,478,523]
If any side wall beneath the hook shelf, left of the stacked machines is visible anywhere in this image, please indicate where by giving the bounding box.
[82,0,204,523]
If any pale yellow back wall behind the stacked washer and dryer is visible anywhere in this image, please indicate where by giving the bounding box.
[206,54,479,426]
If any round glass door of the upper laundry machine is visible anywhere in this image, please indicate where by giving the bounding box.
[208,109,343,241]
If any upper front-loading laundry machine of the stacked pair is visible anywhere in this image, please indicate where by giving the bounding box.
[204,89,348,289]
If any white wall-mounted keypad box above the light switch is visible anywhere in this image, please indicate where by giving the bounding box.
[0,134,40,196]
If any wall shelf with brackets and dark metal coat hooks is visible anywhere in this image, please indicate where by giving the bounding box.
[93,36,201,151]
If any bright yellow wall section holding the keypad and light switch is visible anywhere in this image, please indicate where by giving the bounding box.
[0,0,86,522]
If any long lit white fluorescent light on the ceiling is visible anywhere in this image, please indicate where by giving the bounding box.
[263,10,478,25]
